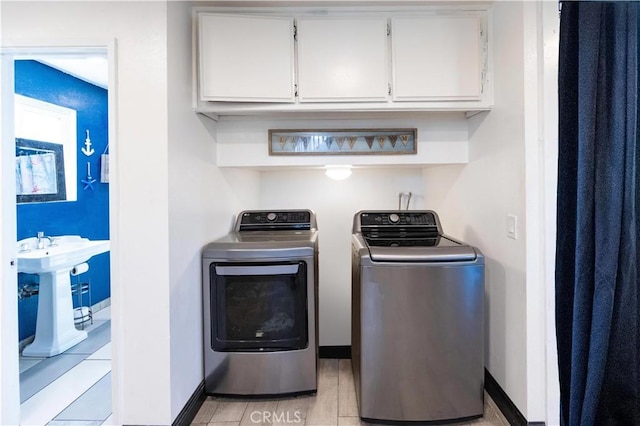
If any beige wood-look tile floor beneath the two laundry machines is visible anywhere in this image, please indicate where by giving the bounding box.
[191,359,509,426]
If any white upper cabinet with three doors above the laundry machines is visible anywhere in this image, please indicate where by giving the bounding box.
[194,6,493,115]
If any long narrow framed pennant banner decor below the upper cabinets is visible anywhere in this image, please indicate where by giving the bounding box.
[269,129,418,155]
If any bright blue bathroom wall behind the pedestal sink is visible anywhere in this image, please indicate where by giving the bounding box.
[15,60,111,340]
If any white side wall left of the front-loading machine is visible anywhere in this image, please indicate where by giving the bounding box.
[168,2,259,423]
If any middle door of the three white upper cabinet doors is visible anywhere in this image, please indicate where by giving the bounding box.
[298,18,389,102]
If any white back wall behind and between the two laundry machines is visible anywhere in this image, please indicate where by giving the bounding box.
[260,167,425,346]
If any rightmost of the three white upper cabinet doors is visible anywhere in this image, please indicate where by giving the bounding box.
[391,15,482,101]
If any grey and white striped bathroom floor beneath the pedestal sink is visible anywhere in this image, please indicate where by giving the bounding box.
[20,308,111,426]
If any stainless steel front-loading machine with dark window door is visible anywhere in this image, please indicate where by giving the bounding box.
[202,210,318,396]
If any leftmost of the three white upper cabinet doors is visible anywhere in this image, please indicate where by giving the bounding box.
[198,13,295,102]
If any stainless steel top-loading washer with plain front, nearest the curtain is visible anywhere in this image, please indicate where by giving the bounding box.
[351,210,484,422]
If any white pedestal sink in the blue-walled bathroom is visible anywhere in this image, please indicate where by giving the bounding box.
[18,235,110,357]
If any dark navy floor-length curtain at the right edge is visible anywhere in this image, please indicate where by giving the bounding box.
[556,2,640,426]
